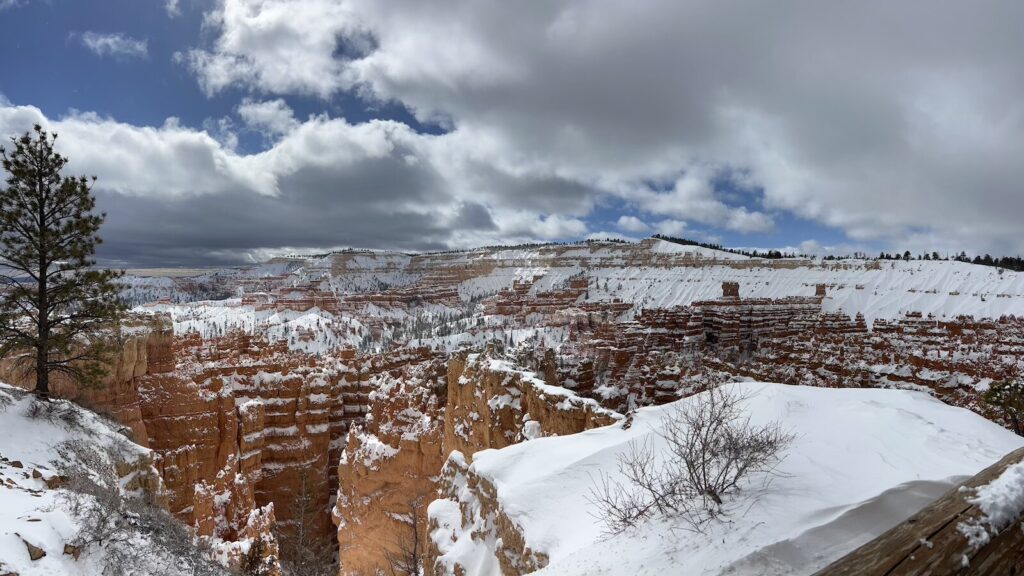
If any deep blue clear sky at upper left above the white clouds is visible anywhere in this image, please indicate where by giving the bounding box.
[0,0,436,153]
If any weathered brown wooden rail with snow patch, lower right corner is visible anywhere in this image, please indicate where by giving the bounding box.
[816,448,1024,576]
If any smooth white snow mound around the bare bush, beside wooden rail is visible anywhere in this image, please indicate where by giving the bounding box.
[428,382,1024,576]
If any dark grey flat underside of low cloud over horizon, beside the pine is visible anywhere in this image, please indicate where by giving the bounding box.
[99,193,446,268]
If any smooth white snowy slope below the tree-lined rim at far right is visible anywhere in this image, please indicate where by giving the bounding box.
[581,255,1024,323]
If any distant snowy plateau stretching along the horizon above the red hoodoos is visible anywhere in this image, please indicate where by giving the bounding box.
[125,240,1024,353]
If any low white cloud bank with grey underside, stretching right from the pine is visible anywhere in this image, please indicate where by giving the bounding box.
[0,99,588,266]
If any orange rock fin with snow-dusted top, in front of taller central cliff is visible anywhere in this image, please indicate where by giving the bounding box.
[334,359,447,575]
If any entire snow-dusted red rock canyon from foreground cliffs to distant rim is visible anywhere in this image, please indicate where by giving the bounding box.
[0,239,1024,575]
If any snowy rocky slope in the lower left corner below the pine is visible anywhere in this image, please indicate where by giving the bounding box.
[0,383,268,576]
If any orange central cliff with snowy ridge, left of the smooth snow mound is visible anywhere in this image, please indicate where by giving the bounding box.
[334,346,621,575]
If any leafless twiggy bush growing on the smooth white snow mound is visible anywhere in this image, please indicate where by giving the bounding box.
[590,387,794,535]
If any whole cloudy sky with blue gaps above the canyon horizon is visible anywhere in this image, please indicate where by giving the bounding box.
[0,0,1024,268]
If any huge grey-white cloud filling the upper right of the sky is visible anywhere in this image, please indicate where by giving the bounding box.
[174,0,1024,255]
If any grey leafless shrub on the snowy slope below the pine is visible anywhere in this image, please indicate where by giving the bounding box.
[56,440,226,576]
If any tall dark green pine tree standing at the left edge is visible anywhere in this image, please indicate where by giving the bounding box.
[0,125,124,398]
